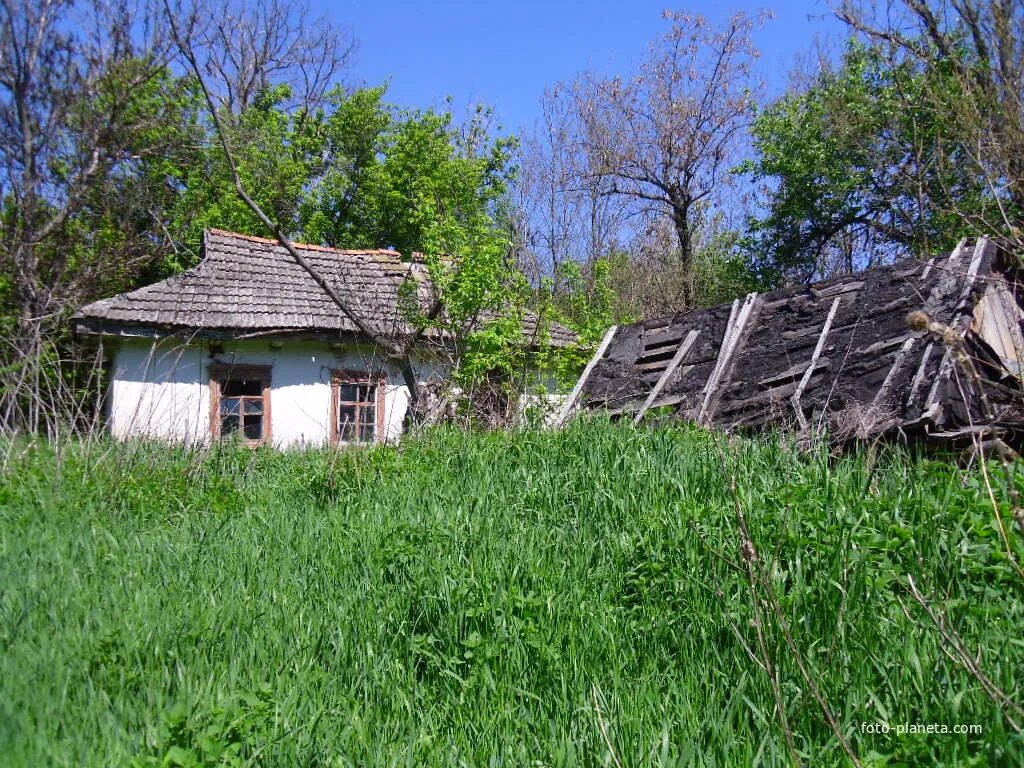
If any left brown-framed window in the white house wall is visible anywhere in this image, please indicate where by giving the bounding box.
[210,365,270,445]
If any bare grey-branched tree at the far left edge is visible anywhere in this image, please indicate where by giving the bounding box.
[0,0,180,429]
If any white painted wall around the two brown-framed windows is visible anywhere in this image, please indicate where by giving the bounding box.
[109,339,445,447]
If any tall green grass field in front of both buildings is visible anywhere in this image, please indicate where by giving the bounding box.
[0,423,1024,767]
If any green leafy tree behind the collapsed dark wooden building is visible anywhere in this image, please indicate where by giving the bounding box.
[742,43,987,280]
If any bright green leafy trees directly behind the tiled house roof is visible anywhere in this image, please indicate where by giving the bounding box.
[149,88,526,383]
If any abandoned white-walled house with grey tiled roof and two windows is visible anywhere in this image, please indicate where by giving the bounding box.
[74,229,574,446]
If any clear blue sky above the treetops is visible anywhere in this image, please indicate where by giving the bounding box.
[323,0,842,132]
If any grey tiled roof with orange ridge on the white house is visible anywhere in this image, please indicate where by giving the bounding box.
[73,229,575,346]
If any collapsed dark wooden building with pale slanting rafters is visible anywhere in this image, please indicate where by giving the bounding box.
[561,239,1024,439]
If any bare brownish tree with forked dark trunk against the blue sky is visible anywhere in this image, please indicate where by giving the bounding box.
[573,11,761,305]
